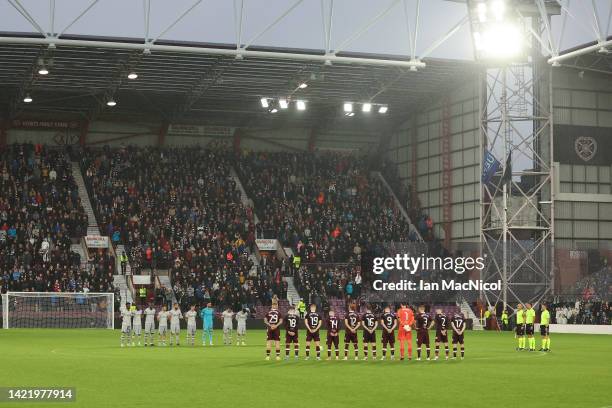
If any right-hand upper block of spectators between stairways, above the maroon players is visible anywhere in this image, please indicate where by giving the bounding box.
[237,152,417,263]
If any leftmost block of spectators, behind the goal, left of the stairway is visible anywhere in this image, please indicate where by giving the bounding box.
[0,144,112,293]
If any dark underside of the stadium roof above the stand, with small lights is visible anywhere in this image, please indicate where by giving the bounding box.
[0,37,476,130]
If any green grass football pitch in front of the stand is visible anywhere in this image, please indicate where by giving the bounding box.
[0,329,612,408]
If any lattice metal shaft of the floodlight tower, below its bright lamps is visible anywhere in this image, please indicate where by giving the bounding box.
[480,3,554,309]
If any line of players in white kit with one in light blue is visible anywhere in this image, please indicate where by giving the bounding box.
[121,303,248,347]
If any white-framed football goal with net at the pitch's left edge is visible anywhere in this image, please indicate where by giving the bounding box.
[2,292,115,329]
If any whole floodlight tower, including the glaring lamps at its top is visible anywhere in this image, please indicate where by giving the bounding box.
[467,0,554,308]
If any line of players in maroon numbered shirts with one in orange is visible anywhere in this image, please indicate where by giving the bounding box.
[264,302,466,360]
